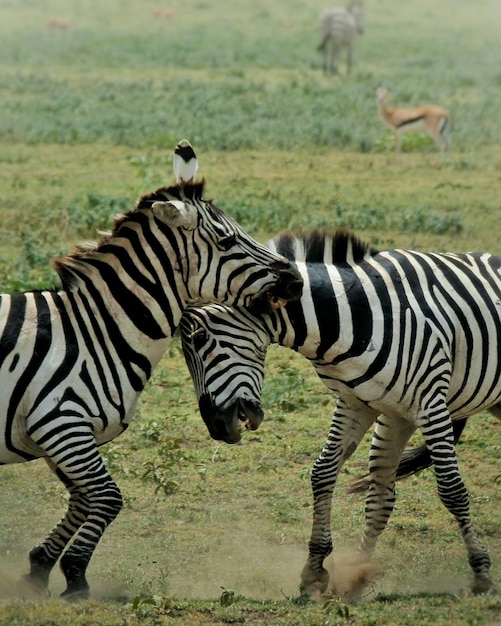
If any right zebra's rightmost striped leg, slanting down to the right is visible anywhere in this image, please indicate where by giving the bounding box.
[421,412,494,593]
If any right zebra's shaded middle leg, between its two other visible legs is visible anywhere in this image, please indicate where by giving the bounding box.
[359,415,416,561]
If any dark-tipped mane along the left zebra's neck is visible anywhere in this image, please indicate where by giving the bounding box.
[52,179,207,289]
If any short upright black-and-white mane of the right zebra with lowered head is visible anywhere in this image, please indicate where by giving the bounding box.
[268,229,378,265]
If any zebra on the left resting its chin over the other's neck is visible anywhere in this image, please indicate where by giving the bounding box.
[0,140,301,600]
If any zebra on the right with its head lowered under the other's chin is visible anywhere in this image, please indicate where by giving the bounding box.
[180,231,501,596]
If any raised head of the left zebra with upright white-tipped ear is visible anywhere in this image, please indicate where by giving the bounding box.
[133,140,302,313]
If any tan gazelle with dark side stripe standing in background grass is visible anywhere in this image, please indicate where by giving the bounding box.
[376,87,449,160]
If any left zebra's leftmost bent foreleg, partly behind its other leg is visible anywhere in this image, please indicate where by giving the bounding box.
[24,458,89,590]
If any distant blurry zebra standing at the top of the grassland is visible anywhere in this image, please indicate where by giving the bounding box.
[318,0,365,74]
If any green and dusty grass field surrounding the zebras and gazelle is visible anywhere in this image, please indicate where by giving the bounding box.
[0,0,501,626]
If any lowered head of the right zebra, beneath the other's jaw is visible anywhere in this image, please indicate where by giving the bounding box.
[180,304,270,443]
